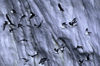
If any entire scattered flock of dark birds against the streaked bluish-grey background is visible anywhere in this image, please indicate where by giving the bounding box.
[3,3,91,64]
